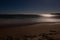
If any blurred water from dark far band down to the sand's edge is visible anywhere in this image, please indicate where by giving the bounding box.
[0,17,60,26]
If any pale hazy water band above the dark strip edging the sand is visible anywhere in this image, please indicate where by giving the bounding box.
[0,17,60,24]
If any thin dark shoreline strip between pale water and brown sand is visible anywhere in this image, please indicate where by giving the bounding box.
[0,22,60,28]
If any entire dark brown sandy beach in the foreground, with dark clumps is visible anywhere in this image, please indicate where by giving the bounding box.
[0,24,60,40]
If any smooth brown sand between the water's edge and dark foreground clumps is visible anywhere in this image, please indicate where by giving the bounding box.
[0,24,60,40]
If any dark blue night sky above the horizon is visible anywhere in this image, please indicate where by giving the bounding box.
[0,0,60,13]
